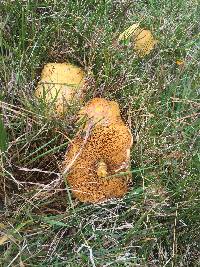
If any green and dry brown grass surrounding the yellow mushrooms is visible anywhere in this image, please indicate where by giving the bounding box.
[0,0,200,267]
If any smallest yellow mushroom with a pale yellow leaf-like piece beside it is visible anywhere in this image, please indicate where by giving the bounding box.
[118,23,157,57]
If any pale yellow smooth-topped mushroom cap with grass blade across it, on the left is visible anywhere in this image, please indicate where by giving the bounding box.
[35,63,86,114]
